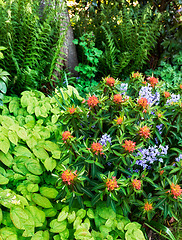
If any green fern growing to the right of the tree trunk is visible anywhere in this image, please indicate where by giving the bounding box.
[97,3,161,77]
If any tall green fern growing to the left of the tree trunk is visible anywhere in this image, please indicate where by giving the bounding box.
[0,0,67,93]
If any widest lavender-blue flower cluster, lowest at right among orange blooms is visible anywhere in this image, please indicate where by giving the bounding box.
[135,145,168,169]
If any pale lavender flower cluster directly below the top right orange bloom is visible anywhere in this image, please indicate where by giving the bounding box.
[139,85,160,106]
